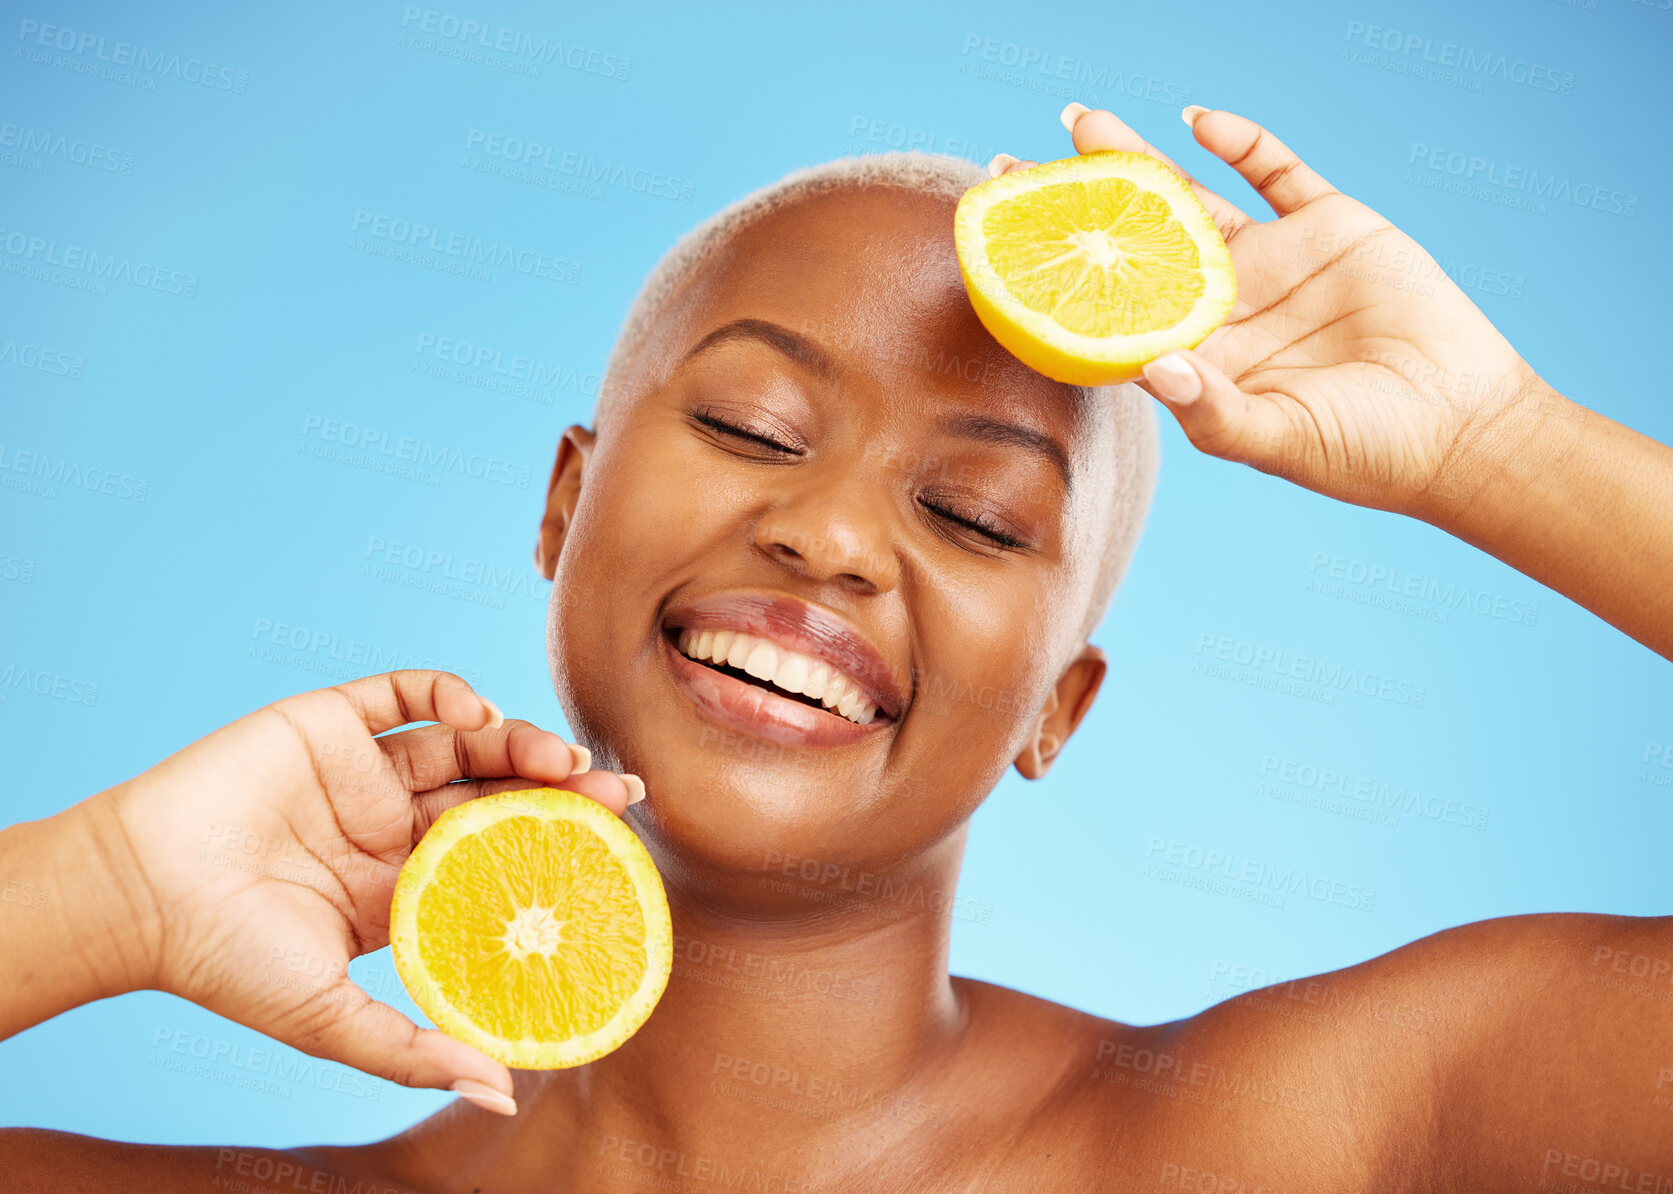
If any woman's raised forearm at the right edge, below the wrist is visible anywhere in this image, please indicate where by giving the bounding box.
[1420,380,1673,659]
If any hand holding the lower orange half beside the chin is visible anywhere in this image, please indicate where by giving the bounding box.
[37,671,644,1114]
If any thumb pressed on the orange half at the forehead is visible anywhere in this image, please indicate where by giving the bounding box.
[1144,353,1300,475]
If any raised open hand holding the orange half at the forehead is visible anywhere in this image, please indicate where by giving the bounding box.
[989,104,1561,520]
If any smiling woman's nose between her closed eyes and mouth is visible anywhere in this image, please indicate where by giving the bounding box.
[755,468,900,594]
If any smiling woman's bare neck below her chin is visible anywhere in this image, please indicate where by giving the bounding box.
[519,828,965,1170]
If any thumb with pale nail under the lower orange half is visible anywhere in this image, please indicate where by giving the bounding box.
[286,978,517,1115]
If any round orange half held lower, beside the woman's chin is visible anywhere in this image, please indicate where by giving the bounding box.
[390,788,674,1070]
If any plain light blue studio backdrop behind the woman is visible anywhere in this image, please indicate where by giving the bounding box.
[0,0,1673,1146]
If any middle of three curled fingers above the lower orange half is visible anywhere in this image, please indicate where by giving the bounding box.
[378,721,592,793]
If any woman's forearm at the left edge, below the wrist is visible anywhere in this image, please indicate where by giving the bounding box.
[0,798,151,1038]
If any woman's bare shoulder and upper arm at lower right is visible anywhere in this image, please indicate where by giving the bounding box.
[1036,913,1673,1192]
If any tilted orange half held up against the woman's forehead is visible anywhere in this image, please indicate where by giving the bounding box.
[954,149,1238,386]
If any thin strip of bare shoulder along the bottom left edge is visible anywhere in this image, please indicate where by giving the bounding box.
[0,1127,423,1194]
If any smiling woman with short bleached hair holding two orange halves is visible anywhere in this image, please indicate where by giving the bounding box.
[0,105,1673,1194]
